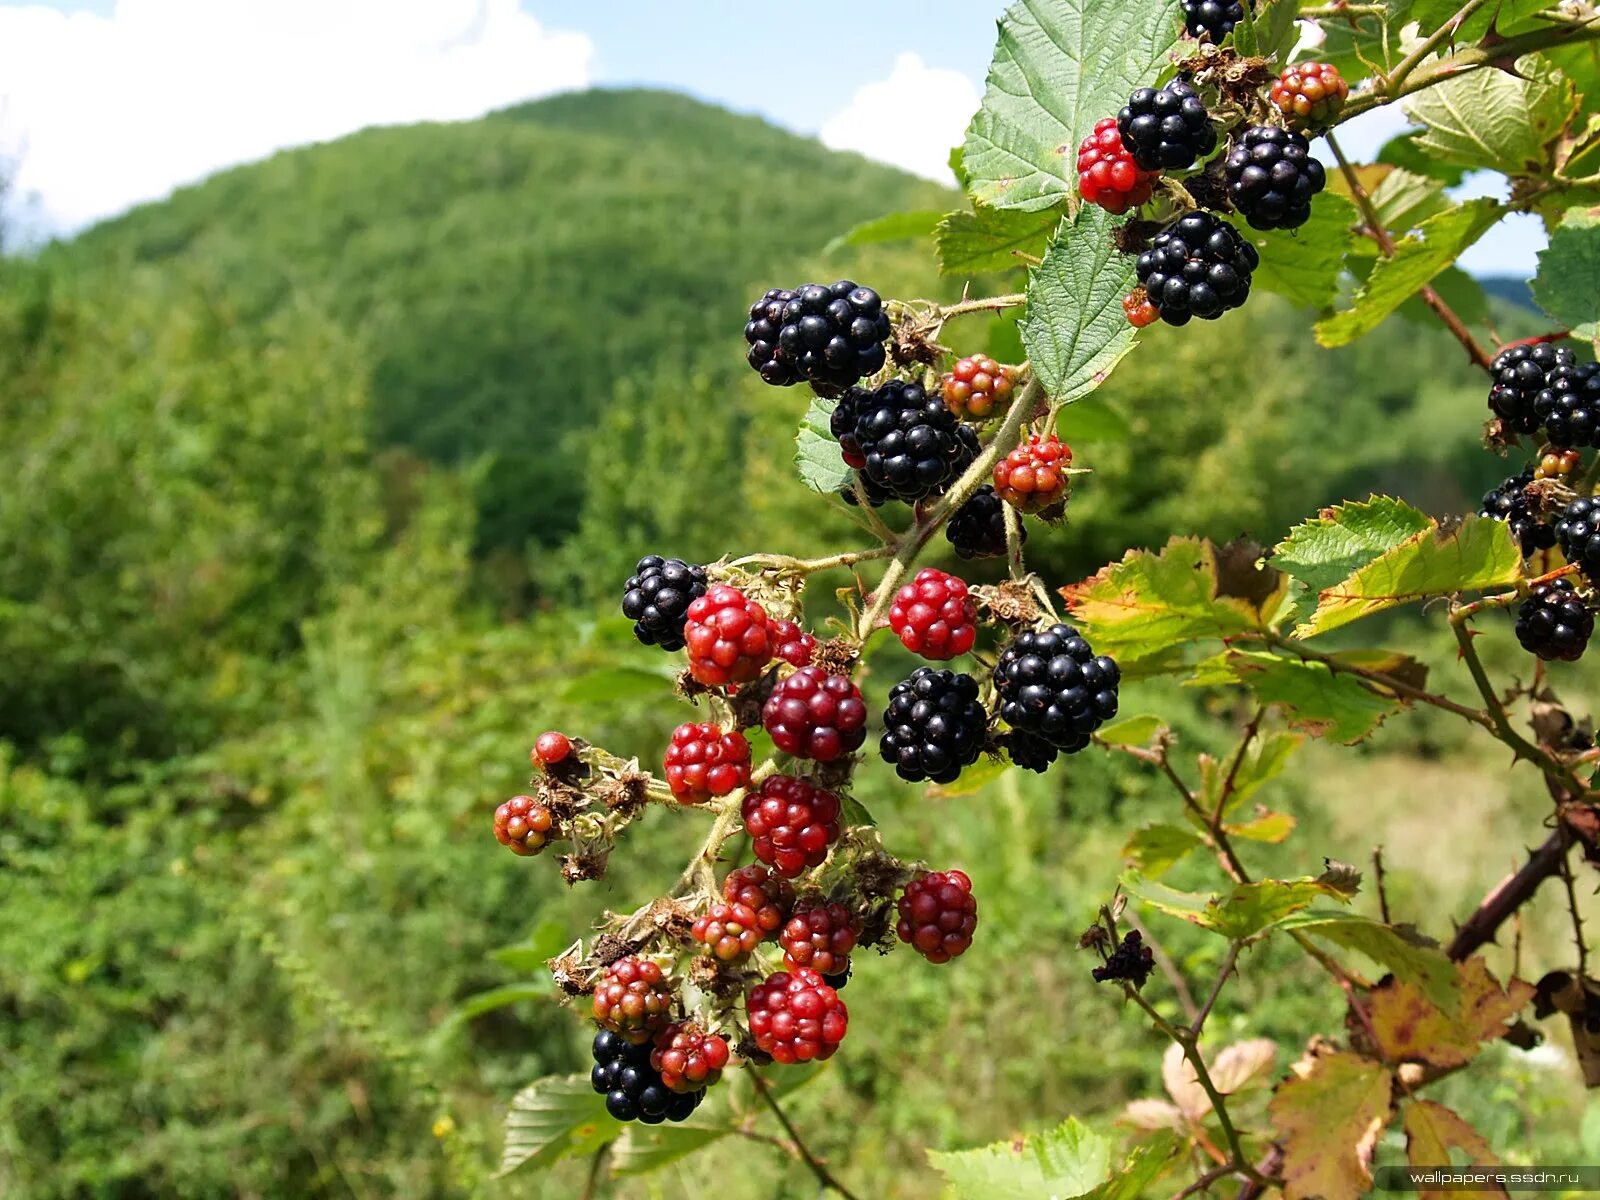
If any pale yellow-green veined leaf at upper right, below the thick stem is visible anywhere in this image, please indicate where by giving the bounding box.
[1405,54,1576,176]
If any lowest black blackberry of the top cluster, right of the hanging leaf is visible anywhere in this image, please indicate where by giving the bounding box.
[1136,213,1261,325]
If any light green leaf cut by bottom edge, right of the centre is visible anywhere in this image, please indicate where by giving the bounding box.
[928,1117,1110,1200]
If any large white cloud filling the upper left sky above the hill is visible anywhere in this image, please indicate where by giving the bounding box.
[0,0,594,230]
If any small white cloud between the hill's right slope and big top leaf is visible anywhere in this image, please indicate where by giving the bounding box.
[819,51,979,184]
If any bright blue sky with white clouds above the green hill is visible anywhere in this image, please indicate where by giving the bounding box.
[0,0,1544,275]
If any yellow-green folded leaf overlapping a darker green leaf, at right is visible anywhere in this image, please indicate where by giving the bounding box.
[1294,515,1522,637]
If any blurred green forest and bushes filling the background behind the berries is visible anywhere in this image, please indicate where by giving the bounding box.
[0,91,1580,1198]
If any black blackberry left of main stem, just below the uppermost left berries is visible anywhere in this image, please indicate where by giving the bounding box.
[856,379,979,504]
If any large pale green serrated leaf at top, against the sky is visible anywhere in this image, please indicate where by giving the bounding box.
[962,0,1182,211]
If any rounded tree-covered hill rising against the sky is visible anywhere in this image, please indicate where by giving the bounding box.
[59,91,950,546]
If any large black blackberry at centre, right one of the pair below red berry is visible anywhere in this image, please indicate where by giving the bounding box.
[995,626,1122,754]
